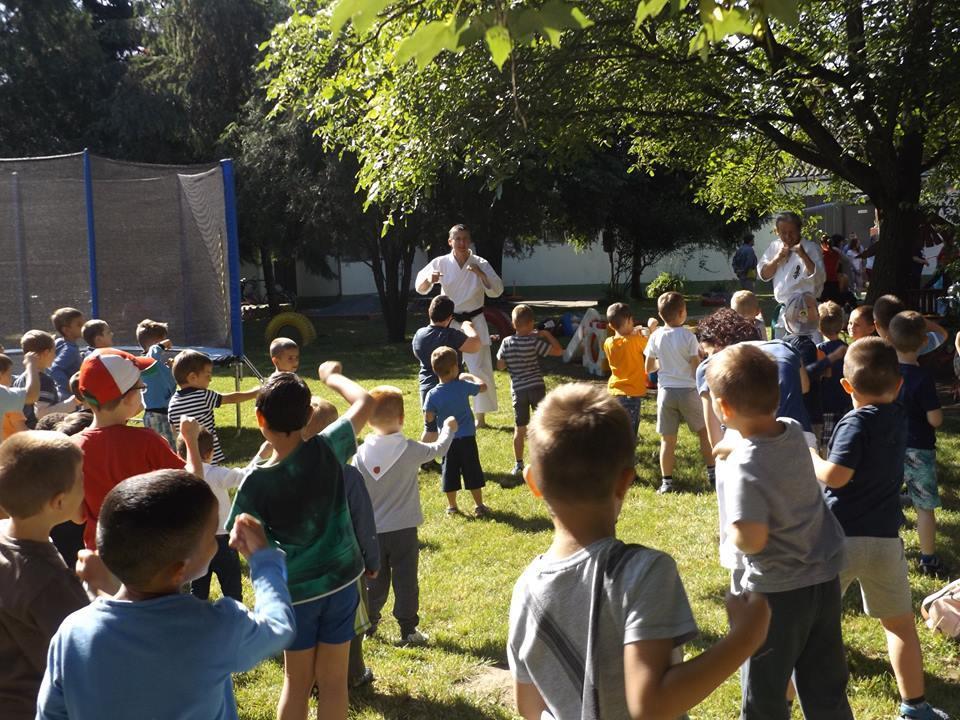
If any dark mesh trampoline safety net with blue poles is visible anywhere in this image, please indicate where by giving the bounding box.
[0,153,239,348]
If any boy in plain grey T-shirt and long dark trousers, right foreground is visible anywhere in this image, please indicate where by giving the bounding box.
[706,344,853,720]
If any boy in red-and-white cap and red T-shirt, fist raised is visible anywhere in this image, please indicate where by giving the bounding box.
[75,348,203,550]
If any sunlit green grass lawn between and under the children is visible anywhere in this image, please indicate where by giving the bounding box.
[206,312,960,720]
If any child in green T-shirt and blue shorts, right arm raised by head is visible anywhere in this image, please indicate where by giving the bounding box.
[228,362,373,720]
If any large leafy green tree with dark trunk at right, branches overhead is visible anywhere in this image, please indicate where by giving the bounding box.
[270,0,960,295]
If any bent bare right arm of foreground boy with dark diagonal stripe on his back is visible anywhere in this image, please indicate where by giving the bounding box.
[624,593,770,720]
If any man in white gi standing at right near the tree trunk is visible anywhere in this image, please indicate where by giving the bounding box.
[757,212,827,337]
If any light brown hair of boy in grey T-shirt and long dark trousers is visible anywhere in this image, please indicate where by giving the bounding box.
[707,344,780,417]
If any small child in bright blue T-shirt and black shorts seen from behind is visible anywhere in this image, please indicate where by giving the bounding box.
[423,347,490,518]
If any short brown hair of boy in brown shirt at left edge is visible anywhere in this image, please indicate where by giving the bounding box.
[0,430,83,518]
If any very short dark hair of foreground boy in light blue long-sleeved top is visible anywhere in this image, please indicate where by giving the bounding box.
[97,470,217,587]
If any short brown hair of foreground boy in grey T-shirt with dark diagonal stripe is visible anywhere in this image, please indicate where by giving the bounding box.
[527,383,637,503]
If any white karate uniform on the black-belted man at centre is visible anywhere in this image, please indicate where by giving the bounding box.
[414,251,503,413]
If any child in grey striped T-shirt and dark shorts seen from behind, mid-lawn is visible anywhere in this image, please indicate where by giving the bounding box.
[497,305,563,479]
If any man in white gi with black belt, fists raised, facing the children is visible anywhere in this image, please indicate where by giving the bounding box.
[416,225,503,427]
